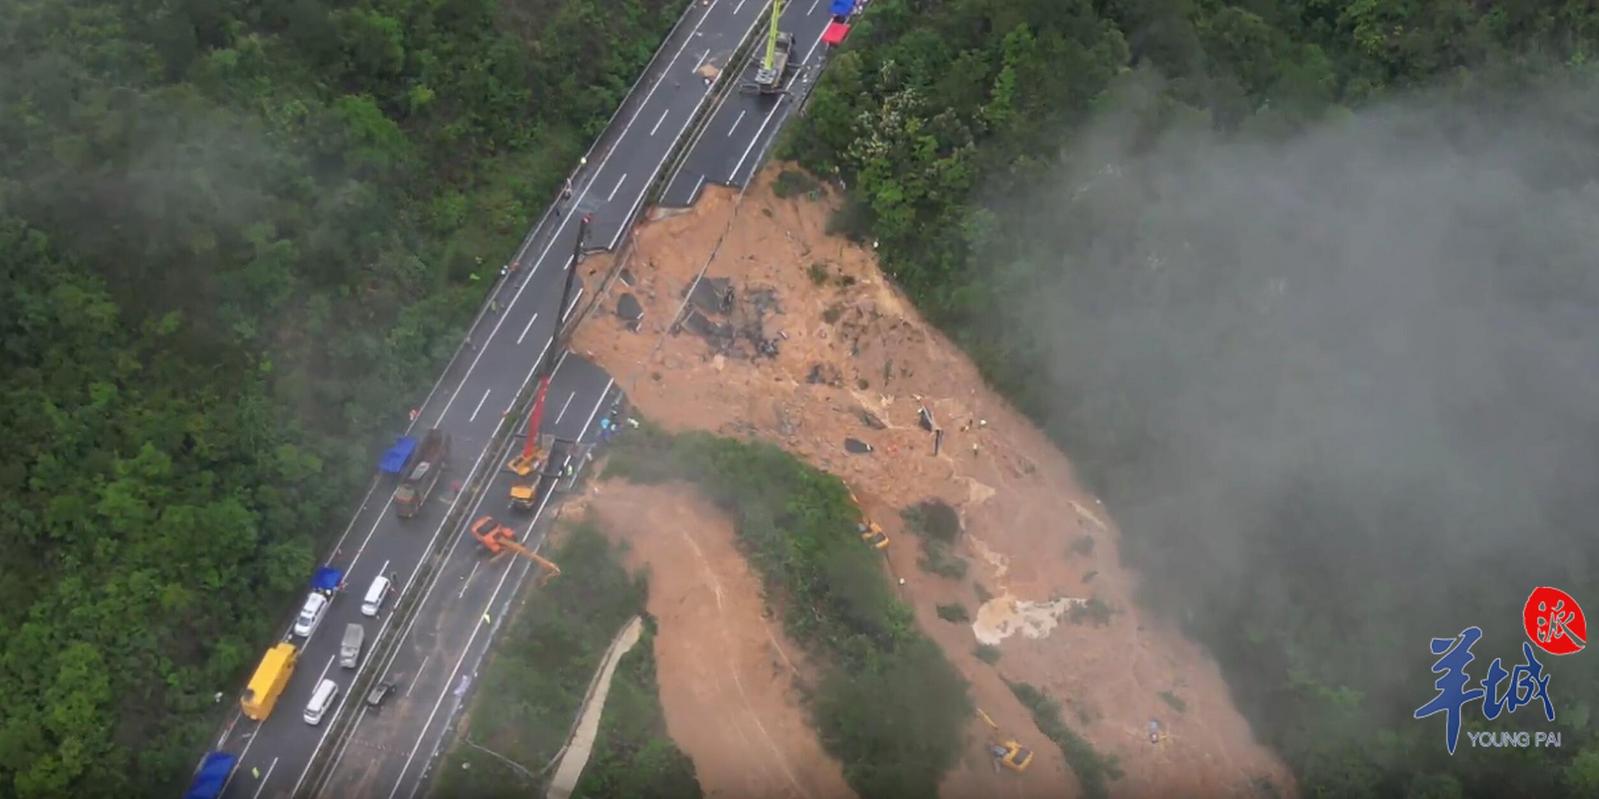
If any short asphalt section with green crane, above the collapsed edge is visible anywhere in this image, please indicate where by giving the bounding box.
[660,0,833,208]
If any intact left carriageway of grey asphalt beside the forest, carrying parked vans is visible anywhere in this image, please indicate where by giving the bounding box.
[199,0,764,797]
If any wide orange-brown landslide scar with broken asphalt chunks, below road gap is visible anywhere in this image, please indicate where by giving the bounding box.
[574,168,1294,797]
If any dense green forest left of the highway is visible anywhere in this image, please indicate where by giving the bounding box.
[0,0,683,797]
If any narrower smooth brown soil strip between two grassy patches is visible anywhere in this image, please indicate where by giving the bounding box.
[574,481,854,799]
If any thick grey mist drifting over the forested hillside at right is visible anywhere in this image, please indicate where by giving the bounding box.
[997,73,1599,789]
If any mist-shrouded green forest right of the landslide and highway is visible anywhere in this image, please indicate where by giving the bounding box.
[780,0,1599,799]
